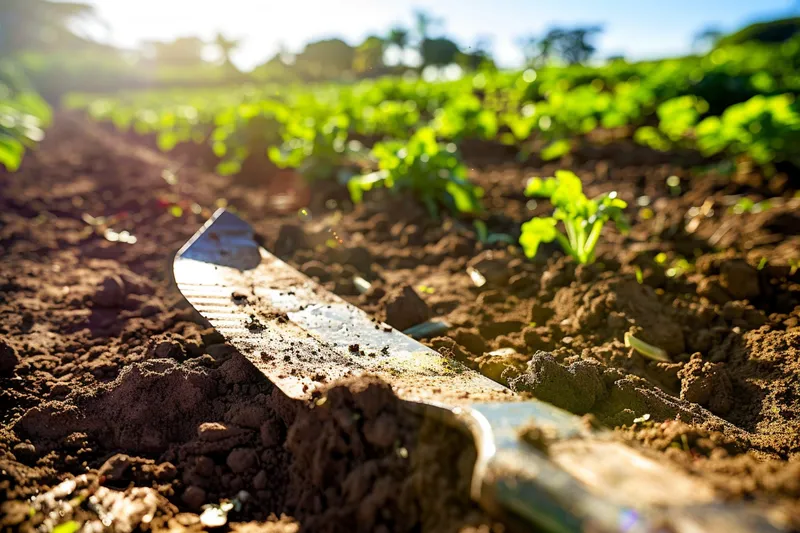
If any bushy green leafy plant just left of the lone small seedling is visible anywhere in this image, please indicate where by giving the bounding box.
[347,127,483,216]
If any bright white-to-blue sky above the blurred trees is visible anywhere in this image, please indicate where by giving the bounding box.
[84,0,800,68]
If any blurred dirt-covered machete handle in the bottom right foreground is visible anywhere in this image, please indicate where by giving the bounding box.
[429,400,786,533]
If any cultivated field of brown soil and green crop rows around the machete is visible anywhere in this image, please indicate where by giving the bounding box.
[0,32,800,533]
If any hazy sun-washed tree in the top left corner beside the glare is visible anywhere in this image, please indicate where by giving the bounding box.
[0,0,95,55]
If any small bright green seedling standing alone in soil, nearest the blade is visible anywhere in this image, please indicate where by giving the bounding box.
[519,170,629,264]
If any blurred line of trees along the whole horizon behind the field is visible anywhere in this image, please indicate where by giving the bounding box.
[0,0,800,93]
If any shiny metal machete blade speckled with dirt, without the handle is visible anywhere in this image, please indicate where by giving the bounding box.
[174,209,519,405]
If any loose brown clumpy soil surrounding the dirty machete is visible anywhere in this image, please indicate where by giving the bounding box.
[0,114,800,532]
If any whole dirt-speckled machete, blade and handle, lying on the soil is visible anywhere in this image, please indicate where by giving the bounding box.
[173,209,783,533]
